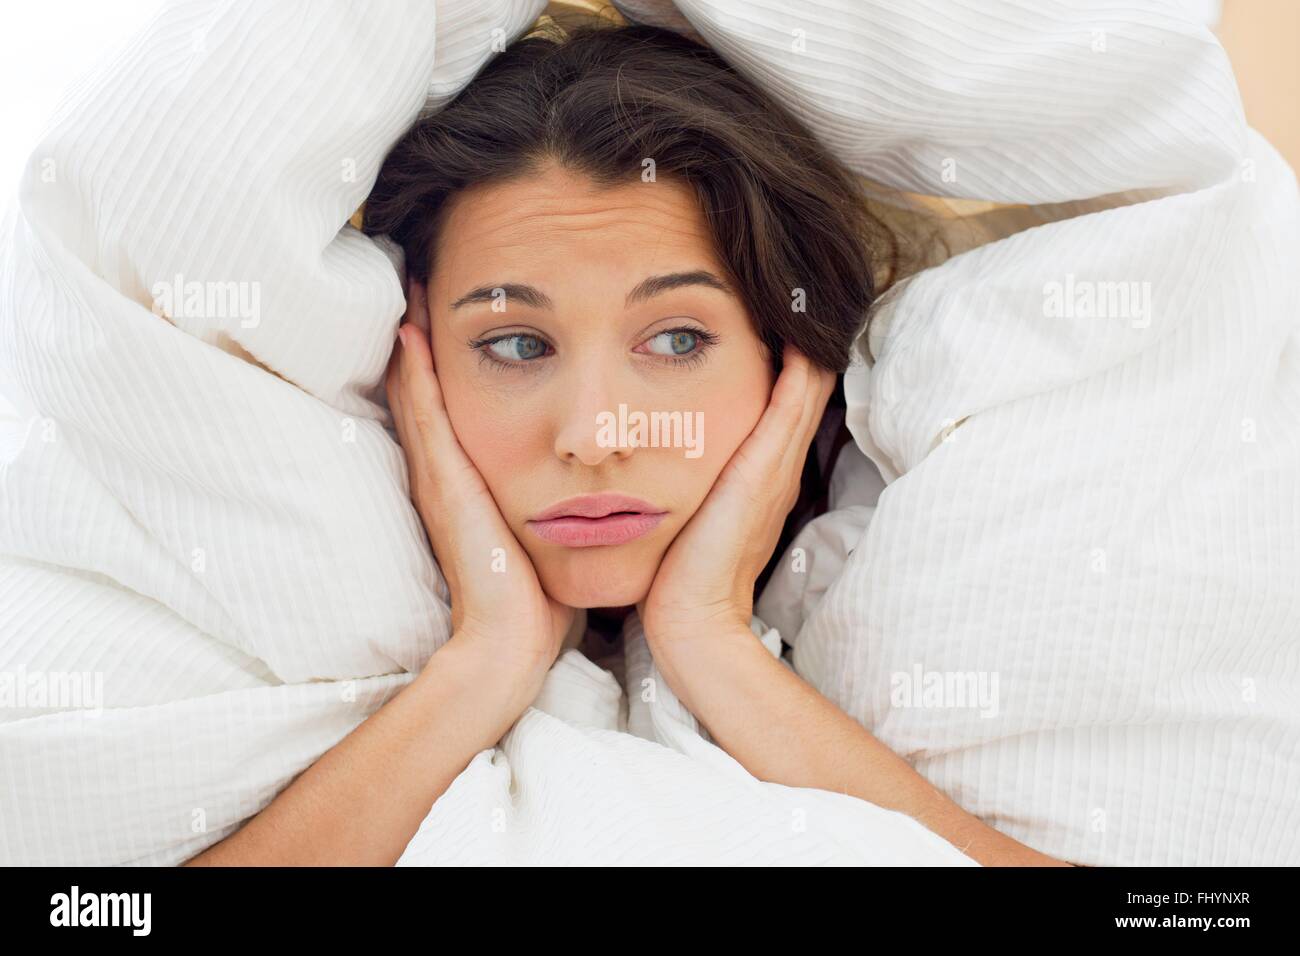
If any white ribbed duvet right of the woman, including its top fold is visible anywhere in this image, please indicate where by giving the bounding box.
[702,0,1300,865]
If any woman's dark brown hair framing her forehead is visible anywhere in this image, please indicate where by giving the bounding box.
[363,23,897,372]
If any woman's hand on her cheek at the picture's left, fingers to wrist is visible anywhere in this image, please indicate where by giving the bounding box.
[387,282,575,683]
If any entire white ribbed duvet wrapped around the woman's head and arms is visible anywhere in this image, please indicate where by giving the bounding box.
[0,0,1300,865]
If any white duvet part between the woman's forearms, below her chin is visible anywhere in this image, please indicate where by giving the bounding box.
[398,613,975,866]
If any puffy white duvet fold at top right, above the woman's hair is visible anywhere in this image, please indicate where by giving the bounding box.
[676,0,1244,203]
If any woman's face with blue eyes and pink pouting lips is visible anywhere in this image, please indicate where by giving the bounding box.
[428,165,775,607]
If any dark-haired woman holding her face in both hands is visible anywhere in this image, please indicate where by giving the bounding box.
[190,18,1061,864]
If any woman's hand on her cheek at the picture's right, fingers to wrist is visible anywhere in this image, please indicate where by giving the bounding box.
[637,343,836,645]
